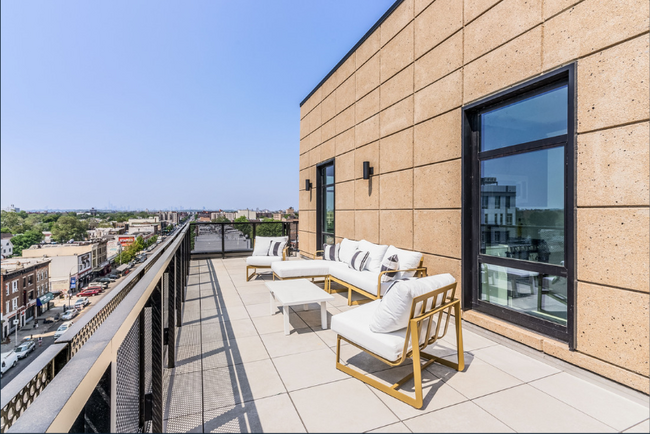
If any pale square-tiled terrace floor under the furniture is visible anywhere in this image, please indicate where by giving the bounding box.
[165,258,650,433]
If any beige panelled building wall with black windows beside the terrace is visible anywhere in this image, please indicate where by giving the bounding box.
[299,0,650,393]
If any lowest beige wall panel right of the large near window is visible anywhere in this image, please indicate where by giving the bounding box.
[576,284,650,376]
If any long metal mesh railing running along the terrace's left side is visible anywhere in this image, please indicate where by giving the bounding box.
[1,223,191,432]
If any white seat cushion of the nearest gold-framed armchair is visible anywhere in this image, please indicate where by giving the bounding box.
[332,300,406,361]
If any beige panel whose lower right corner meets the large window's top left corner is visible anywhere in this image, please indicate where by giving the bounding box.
[415,69,463,123]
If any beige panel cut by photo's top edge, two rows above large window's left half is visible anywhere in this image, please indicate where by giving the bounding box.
[464,0,542,63]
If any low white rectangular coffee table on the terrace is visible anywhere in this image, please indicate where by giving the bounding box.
[266,279,334,335]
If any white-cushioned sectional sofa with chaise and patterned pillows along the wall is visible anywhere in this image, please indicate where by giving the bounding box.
[271,238,427,305]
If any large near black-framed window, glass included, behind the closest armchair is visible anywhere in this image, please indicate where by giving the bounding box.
[463,65,575,345]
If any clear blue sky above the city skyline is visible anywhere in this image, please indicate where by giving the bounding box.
[0,0,394,210]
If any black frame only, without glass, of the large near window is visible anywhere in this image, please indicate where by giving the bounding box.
[461,63,577,350]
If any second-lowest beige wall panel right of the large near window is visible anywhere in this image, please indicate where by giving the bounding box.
[576,208,650,292]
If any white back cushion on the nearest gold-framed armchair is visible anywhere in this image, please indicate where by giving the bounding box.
[369,273,456,333]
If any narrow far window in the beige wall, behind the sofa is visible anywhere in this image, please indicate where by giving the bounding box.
[316,161,335,250]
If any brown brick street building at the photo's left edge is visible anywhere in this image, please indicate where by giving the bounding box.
[0,258,52,339]
